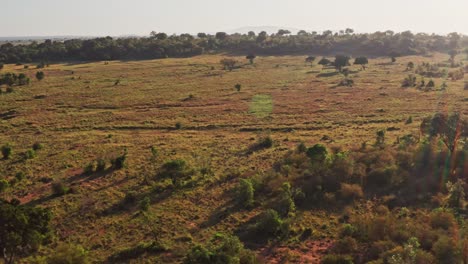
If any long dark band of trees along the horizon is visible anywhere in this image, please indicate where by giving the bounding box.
[0,29,468,63]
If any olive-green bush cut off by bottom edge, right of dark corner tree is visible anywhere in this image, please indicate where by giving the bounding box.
[47,244,90,264]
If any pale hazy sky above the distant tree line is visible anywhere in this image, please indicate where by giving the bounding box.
[0,0,468,37]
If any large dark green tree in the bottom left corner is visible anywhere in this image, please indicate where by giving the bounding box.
[0,200,52,264]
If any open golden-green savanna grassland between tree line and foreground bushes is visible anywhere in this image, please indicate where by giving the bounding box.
[0,53,468,263]
